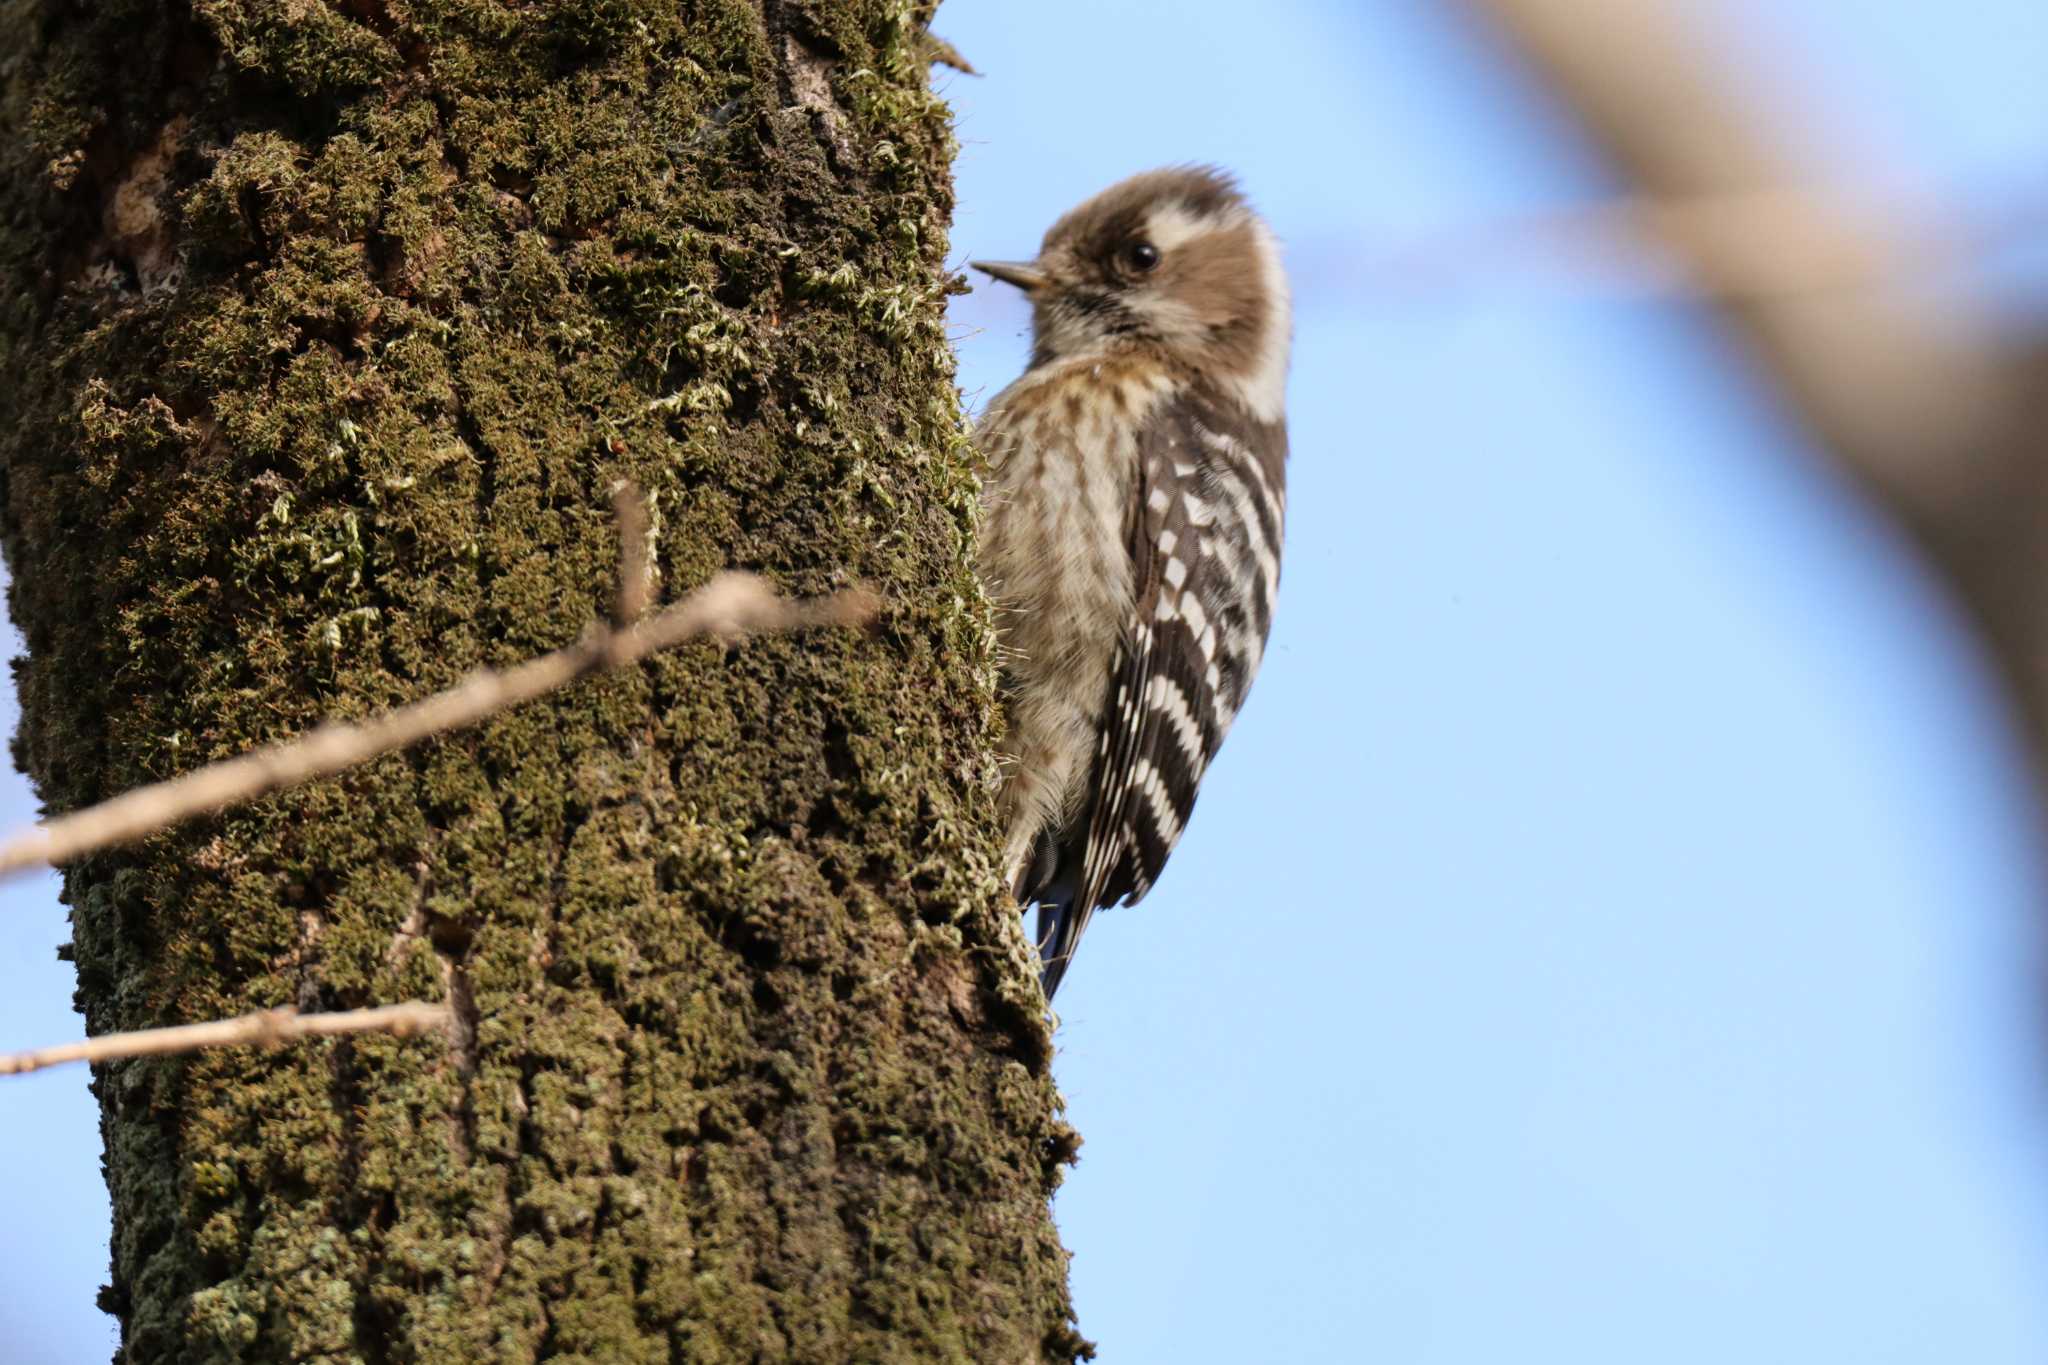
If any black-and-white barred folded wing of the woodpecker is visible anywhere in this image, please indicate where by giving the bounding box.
[1038,388,1286,995]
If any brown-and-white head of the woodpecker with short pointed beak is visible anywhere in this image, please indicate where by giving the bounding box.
[971,168,1290,420]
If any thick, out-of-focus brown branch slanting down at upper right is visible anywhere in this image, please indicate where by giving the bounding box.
[1470,0,2048,810]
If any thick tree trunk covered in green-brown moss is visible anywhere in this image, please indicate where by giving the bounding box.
[0,0,1083,1361]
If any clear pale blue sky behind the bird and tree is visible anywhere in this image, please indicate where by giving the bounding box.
[0,0,2048,1365]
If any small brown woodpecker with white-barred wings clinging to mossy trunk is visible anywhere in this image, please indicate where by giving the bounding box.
[971,168,1292,1001]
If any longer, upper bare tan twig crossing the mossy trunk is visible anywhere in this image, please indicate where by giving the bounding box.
[0,573,877,876]
